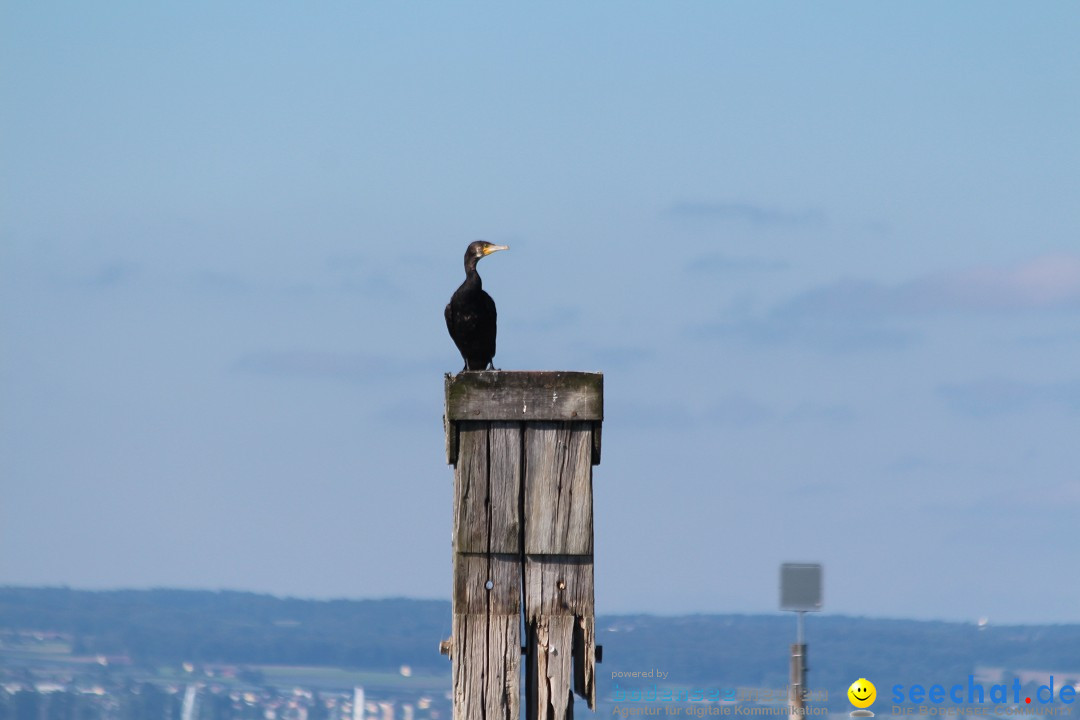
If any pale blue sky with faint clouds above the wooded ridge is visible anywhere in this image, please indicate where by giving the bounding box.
[0,2,1080,622]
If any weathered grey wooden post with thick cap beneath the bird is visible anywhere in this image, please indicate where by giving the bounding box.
[444,370,604,720]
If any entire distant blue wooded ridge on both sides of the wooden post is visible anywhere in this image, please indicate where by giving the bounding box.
[0,587,1080,695]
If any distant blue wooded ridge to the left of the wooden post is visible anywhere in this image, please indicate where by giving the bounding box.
[0,587,450,670]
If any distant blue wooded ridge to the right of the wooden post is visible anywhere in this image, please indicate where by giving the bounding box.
[597,613,1080,702]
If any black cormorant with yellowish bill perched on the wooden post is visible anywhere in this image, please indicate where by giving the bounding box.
[445,240,510,371]
